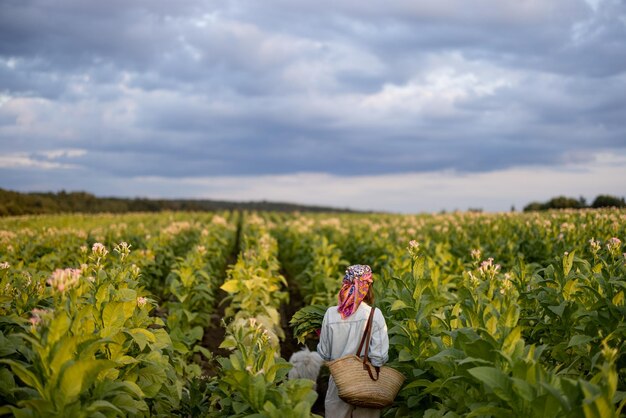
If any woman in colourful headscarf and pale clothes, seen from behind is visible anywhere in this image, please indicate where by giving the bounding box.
[317,265,389,418]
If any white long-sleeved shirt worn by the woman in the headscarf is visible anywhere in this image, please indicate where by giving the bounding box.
[317,302,389,366]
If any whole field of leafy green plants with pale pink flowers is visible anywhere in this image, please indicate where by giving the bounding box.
[0,210,626,418]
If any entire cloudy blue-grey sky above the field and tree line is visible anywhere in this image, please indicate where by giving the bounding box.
[0,0,626,213]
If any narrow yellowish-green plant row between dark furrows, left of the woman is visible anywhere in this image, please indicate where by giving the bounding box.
[209,214,317,418]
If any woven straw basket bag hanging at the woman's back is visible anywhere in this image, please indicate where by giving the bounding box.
[327,354,404,409]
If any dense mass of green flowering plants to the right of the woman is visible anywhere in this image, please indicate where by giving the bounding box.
[282,211,626,417]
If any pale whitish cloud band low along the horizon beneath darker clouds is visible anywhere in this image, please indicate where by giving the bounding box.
[0,149,626,213]
